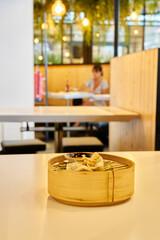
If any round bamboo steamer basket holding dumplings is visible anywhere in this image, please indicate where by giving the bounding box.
[48,153,135,206]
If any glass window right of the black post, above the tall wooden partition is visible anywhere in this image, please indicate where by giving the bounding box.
[118,0,160,56]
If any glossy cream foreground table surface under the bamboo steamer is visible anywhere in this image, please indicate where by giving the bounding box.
[0,152,160,240]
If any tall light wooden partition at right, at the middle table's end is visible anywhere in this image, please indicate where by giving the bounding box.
[109,49,160,151]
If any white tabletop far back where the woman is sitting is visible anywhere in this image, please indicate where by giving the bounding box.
[48,92,110,101]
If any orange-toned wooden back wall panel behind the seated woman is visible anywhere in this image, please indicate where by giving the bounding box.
[35,64,110,106]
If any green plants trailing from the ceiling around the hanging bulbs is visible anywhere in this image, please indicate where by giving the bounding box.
[34,0,158,45]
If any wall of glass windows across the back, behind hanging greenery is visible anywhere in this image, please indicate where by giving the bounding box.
[34,0,160,64]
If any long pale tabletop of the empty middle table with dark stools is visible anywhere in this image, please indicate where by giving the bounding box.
[0,106,139,123]
